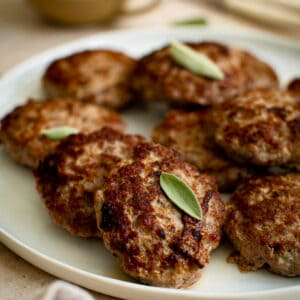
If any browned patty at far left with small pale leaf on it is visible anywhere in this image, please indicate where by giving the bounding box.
[0,98,126,168]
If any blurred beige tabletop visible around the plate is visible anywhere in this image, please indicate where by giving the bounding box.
[0,0,300,300]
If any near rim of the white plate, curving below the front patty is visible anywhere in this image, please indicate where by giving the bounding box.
[0,228,300,300]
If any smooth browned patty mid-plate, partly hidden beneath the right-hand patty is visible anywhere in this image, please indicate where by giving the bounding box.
[152,109,255,192]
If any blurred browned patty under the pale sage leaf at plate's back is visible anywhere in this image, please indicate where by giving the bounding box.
[133,42,278,105]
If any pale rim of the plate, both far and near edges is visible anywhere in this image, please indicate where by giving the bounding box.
[0,26,300,299]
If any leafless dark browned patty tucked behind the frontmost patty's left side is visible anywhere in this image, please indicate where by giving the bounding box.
[35,128,144,237]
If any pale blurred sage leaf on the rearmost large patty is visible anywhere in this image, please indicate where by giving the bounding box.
[170,41,224,80]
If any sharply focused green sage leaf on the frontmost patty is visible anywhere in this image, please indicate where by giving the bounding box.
[159,173,202,220]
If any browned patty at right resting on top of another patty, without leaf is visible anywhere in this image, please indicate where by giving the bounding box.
[215,90,300,167]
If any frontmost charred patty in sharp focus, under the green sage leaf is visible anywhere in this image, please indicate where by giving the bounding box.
[95,143,224,288]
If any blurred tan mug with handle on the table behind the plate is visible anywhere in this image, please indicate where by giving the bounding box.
[27,0,160,25]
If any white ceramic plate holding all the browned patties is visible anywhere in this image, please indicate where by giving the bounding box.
[0,28,300,300]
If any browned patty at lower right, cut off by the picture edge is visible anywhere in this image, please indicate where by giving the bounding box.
[224,174,300,276]
